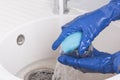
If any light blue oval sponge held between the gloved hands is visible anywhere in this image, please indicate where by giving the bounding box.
[61,32,82,53]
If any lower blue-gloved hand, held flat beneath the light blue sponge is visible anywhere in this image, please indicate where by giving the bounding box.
[58,49,120,73]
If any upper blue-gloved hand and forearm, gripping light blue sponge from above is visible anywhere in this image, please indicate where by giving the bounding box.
[52,0,120,55]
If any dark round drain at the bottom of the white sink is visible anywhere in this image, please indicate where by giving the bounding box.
[24,69,54,80]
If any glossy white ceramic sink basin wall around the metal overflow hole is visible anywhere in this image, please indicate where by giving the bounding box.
[0,15,120,80]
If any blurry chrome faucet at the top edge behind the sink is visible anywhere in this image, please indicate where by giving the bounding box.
[53,0,69,14]
